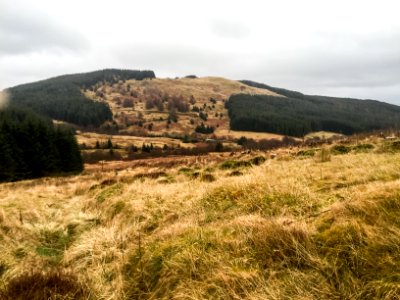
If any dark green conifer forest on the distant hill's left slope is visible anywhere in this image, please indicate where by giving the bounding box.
[8,69,155,127]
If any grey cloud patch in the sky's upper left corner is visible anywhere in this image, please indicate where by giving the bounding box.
[0,4,88,55]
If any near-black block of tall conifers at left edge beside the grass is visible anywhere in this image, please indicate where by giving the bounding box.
[0,107,83,181]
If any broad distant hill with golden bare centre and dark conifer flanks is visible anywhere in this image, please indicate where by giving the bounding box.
[8,69,400,142]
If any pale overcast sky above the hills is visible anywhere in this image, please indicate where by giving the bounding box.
[0,0,400,105]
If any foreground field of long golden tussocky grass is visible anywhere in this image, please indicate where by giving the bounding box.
[0,138,400,299]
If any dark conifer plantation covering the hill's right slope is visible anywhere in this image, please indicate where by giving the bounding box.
[231,81,400,136]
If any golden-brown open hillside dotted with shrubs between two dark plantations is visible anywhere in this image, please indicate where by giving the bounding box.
[85,77,279,136]
